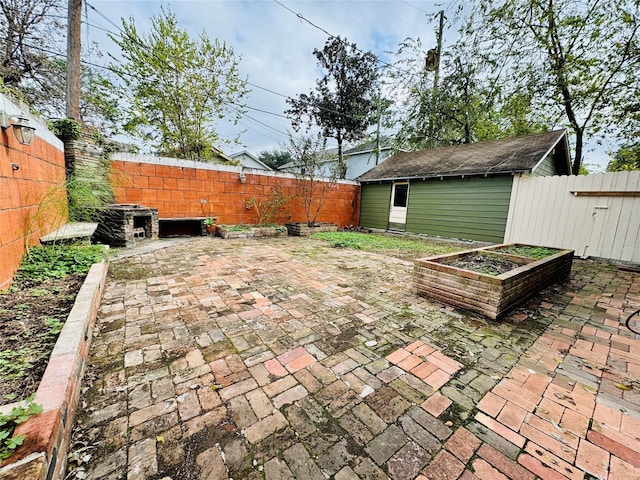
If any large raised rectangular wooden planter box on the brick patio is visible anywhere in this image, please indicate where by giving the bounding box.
[414,244,573,319]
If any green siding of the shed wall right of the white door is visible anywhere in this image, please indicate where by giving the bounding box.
[408,175,513,242]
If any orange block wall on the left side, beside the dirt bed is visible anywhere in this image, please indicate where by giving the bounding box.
[0,122,67,290]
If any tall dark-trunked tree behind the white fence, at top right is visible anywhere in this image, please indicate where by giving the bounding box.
[461,0,640,172]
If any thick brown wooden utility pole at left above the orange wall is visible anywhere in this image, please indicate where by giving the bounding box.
[67,0,82,121]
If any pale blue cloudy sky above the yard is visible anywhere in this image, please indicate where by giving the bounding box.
[83,0,607,172]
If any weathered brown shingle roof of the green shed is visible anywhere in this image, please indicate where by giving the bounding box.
[357,130,571,182]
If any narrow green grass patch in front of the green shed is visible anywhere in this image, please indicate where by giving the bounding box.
[312,232,469,258]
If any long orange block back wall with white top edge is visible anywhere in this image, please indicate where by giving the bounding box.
[111,154,360,227]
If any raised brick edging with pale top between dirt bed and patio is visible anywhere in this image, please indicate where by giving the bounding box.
[0,260,108,480]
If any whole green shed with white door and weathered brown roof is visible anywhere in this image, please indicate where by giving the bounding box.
[357,130,571,242]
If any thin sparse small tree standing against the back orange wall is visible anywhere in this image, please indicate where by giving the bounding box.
[283,133,336,227]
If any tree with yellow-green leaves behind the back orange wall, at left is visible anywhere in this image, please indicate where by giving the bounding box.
[111,8,248,161]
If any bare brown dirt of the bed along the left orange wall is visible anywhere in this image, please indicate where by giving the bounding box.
[0,275,84,405]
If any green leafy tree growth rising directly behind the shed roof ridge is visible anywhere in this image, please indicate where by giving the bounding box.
[389,38,545,150]
